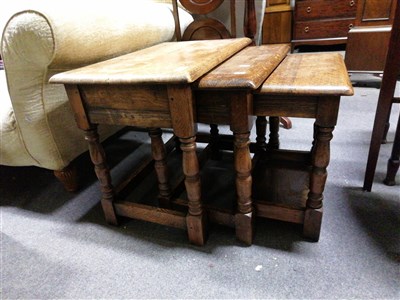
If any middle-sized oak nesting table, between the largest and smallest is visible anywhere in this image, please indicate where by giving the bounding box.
[194,44,290,245]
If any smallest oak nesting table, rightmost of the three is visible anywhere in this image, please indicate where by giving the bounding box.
[253,53,353,241]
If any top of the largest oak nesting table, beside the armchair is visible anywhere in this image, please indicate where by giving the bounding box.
[50,38,251,84]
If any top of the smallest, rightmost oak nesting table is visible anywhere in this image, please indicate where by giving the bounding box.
[259,53,353,96]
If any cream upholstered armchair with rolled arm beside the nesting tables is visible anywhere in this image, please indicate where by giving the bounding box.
[0,0,192,191]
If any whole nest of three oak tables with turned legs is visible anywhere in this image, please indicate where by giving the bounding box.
[51,38,352,245]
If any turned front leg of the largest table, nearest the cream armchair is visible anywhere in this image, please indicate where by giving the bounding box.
[85,126,118,225]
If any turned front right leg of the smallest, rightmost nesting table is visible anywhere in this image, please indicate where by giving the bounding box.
[303,125,334,241]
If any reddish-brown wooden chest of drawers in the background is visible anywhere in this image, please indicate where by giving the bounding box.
[292,0,357,49]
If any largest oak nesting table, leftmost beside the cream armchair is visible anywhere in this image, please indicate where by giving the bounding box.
[50,38,251,245]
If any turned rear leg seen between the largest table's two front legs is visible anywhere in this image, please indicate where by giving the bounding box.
[149,128,171,208]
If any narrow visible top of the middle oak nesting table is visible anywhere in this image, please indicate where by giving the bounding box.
[198,44,290,90]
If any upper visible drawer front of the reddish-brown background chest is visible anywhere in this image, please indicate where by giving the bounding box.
[295,0,357,21]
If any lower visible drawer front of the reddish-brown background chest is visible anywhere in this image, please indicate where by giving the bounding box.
[293,18,355,40]
